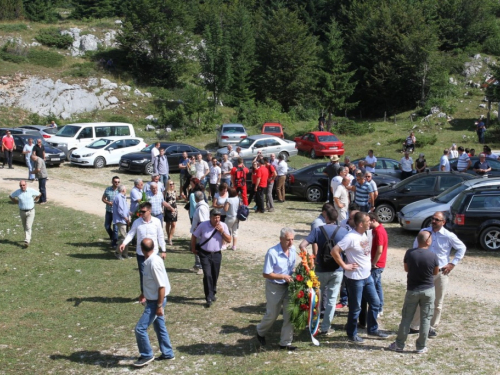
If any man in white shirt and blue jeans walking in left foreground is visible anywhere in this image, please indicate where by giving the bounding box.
[134,238,175,367]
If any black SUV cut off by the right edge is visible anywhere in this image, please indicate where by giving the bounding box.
[447,187,500,251]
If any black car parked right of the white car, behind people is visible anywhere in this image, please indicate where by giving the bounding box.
[119,142,207,174]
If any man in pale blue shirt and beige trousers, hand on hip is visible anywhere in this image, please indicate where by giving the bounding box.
[410,211,467,338]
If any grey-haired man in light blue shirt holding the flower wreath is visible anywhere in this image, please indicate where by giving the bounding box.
[257,228,297,351]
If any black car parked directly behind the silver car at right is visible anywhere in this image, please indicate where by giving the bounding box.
[375,172,477,223]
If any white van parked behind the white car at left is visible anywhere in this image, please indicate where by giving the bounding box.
[48,122,135,160]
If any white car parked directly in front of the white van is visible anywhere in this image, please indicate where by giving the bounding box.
[69,137,147,168]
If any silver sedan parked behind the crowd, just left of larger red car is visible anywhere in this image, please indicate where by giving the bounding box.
[217,134,298,160]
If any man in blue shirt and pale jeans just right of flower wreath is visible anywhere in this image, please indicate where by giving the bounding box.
[299,209,347,335]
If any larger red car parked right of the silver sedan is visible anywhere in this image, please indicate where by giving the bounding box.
[294,132,344,159]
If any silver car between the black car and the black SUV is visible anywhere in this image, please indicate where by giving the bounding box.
[398,177,500,231]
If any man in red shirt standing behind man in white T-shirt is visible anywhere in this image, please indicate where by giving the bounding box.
[359,212,389,327]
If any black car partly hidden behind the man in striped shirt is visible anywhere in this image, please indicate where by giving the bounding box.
[286,163,400,202]
